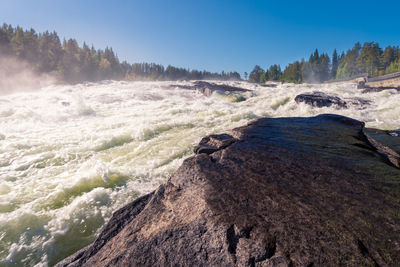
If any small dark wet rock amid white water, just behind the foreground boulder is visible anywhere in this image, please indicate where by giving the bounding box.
[294,92,371,109]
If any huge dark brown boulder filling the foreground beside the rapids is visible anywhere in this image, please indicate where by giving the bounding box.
[59,115,400,266]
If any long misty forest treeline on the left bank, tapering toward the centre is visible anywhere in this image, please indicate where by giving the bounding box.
[0,24,241,83]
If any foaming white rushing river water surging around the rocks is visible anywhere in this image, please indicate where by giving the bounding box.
[0,82,400,266]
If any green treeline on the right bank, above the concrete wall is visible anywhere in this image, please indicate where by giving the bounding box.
[249,42,400,83]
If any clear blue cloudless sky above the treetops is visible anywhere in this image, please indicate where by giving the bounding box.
[0,0,400,73]
